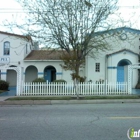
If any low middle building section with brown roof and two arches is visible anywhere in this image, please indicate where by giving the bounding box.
[24,50,72,82]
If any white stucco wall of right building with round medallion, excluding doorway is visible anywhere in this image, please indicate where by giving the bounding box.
[86,32,140,87]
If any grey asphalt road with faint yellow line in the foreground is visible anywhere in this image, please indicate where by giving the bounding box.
[0,103,140,140]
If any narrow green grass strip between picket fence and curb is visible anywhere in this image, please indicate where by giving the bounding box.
[7,95,140,100]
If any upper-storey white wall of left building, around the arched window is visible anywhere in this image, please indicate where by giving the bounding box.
[0,34,33,66]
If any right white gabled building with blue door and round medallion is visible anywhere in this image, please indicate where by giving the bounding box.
[85,27,140,88]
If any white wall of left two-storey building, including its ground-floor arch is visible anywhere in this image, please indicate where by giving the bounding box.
[0,33,33,86]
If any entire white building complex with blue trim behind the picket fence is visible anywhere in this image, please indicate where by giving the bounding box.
[0,27,140,87]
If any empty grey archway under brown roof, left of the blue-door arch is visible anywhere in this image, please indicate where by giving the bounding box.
[25,66,38,82]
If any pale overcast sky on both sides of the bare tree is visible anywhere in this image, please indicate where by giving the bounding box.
[0,0,140,33]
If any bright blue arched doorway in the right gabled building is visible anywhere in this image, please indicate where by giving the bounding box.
[117,59,131,82]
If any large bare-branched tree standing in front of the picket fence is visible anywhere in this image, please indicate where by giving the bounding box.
[4,0,121,97]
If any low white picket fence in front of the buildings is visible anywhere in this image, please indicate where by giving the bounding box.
[20,82,128,96]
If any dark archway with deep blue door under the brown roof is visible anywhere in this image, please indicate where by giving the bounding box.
[44,66,56,82]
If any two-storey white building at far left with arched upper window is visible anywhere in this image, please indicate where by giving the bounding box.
[0,31,34,86]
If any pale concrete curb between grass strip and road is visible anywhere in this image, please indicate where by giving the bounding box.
[0,99,140,105]
